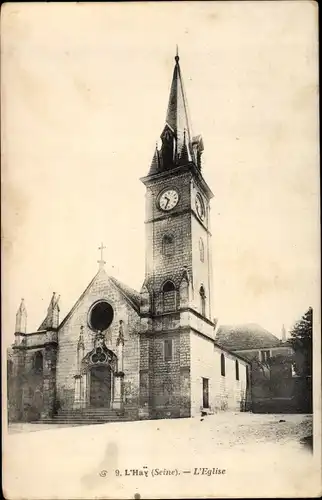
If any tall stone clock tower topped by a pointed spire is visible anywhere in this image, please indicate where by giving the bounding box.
[140,49,213,418]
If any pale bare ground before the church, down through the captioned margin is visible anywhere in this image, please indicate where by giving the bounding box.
[4,413,320,500]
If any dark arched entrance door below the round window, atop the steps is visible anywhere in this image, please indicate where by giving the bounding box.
[90,366,112,408]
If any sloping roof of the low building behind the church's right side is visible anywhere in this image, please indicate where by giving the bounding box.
[216,323,281,351]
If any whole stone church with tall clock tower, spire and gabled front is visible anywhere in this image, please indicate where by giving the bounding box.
[8,54,251,423]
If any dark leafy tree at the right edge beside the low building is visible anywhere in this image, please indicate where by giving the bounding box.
[289,307,313,377]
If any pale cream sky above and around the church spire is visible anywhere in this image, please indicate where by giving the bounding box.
[1,1,320,343]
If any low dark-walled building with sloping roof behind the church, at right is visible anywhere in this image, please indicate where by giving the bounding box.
[216,323,296,413]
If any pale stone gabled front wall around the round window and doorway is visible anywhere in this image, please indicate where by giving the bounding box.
[57,271,140,410]
